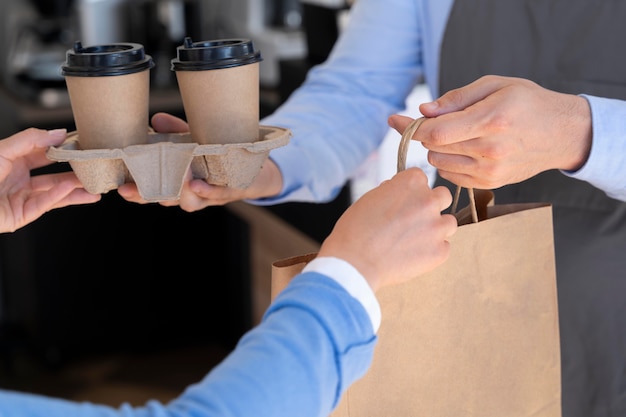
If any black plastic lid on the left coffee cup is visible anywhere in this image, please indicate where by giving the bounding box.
[61,41,154,77]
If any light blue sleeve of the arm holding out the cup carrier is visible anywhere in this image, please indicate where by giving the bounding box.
[250,0,423,205]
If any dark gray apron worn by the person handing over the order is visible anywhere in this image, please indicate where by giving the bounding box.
[437,0,626,417]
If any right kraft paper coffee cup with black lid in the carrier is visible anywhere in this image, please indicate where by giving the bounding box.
[171,37,262,145]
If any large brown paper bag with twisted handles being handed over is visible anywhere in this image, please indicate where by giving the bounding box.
[272,117,561,417]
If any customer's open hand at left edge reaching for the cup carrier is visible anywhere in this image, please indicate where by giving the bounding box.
[0,128,101,233]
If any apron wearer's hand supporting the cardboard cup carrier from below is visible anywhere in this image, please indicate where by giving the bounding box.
[117,113,282,212]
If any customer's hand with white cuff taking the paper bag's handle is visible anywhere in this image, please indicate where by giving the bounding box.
[318,168,457,291]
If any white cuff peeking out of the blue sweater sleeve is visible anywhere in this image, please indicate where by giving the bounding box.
[302,256,381,333]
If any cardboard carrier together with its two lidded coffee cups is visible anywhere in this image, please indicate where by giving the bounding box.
[48,38,291,201]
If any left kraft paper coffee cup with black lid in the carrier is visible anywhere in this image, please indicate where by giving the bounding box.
[62,42,154,149]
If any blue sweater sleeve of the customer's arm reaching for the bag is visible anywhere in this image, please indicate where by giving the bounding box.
[0,271,377,417]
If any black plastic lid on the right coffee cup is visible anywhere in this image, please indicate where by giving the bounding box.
[171,37,263,71]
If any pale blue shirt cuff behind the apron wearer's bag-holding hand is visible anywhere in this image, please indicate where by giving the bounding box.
[563,95,626,201]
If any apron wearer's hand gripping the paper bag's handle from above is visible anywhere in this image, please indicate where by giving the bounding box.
[389,75,591,189]
